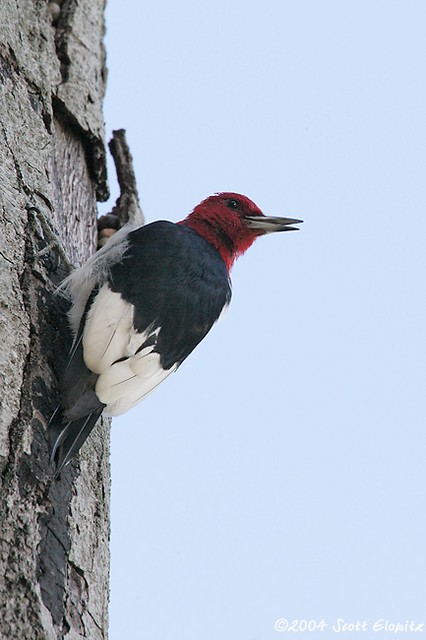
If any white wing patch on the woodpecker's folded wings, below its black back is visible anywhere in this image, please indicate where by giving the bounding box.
[83,284,177,416]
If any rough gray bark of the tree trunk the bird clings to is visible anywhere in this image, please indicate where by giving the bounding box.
[0,0,110,640]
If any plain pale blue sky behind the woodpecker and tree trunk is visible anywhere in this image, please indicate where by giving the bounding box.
[101,0,426,640]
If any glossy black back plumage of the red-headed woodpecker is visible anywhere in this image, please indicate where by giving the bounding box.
[109,221,231,369]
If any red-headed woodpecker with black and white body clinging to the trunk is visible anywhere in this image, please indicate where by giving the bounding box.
[49,192,302,477]
